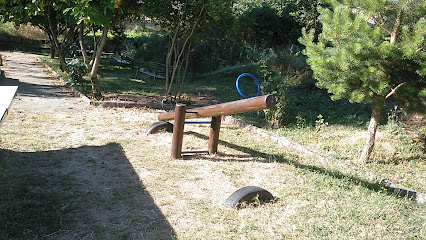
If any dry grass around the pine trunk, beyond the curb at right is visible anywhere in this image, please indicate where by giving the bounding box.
[279,120,426,192]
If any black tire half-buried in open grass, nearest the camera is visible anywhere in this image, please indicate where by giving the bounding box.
[223,186,274,208]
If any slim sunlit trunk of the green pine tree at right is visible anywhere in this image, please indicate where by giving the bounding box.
[359,105,382,163]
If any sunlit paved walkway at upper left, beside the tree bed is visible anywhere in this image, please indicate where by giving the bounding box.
[0,52,89,112]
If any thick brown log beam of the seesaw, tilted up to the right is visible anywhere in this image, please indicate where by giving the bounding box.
[158,95,275,121]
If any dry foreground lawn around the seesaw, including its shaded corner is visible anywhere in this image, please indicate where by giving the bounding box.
[0,108,426,239]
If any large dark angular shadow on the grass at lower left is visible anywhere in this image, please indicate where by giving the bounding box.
[0,143,176,239]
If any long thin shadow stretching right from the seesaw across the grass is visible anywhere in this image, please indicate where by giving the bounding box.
[184,131,418,200]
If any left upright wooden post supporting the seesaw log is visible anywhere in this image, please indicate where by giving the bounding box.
[171,104,186,159]
